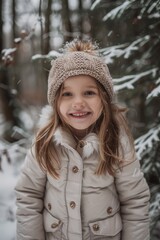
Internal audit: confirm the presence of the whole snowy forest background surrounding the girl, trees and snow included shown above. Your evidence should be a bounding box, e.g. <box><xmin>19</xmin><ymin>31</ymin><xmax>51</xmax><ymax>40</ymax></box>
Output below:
<box><xmin>0</xmin><ymin>0</ymin><xmax>160</xmax><ymax>240</ymax></box>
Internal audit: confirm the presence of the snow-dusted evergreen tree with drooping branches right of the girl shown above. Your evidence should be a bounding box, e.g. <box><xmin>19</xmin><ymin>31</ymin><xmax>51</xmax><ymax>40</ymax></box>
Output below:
<box><xmin>91</xmin><ymin>0</ymin><xmax>160</xmax><ymax>239</ymax></box>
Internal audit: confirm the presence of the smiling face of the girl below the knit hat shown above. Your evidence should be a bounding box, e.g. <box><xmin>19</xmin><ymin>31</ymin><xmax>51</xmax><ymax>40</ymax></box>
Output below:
<box><xmin>58</xmin><ymin>75</ymin><xmax>103</xmax><ymax>133</ymax></box>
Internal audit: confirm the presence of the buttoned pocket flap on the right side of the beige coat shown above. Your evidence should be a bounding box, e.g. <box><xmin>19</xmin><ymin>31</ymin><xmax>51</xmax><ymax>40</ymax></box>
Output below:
<box><xmin>89</xmin><ymin>213</ymin><xmax>122</xmax><ymax>236</ymax></box>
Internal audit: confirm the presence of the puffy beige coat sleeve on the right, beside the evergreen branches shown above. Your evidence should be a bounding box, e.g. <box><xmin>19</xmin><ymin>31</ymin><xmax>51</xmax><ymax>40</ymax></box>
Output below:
<box><xmin>115</xmin><ymin>154</ymin><xmax>150</xmax><ymax>240</ymax></box>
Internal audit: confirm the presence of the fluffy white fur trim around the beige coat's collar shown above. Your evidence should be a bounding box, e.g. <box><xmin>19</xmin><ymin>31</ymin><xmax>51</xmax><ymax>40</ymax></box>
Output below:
<box><xmin>38</xmin><ymin>105</ymin><xmax>99</xmax><ymax>157</ymax></box>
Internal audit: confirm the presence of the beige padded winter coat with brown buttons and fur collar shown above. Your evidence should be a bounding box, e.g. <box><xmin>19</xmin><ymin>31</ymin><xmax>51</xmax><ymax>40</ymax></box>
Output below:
<box><xmin>16</xmin><ymin>106</ymin><xmax>149</xmax><ymax>240</ymax></box>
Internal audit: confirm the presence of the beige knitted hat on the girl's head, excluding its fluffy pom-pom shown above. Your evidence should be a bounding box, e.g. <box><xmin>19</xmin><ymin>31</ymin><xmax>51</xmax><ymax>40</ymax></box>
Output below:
<box><xmin>48</xmin><ymin>45</ymin><xmax>113</xmax><ymax>106</ymax></box>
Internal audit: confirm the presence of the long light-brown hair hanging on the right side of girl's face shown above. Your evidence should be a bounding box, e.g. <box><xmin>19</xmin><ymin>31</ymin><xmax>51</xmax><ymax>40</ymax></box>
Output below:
<box><xmin>94</xmin><ymin>82</ymin><xmax>135</xmax><ymax>176</ymax></box>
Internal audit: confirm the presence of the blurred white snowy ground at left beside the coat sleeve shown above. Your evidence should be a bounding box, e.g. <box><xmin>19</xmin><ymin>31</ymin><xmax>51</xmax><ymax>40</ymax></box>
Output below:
<box><xmin>0</xmin><ymin>142</ymin><xmax>26</xmax><ymax>240</ymax></box>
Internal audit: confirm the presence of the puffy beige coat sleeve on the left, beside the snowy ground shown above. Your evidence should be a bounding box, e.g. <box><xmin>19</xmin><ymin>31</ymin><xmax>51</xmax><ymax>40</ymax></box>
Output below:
<box><xmin>15</xmin><ymin>148</ymin><xmax>46</xmax><ymax>240</ymax></box>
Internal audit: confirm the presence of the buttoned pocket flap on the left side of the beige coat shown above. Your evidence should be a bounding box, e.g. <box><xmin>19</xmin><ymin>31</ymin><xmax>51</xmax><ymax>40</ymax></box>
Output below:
<box><xmin>43</xmin><ymin>209</ymin><xmax>62</xmax><ymax>232</ymax></box>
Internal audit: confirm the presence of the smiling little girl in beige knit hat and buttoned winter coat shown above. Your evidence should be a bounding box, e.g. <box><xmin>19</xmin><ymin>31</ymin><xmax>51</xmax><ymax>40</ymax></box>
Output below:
<box><xmin>16</xmin><ymin>40</ymin><xmax>149</xmax><ymax>240</ymax></box>
